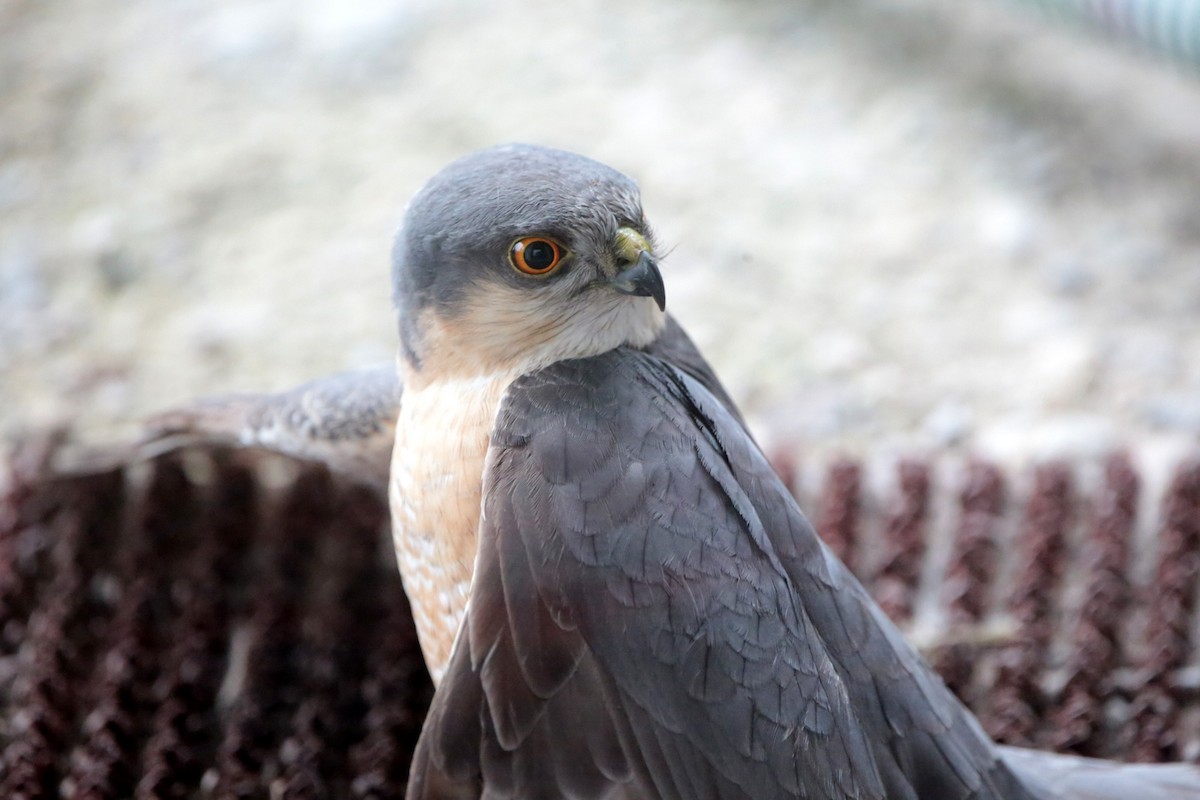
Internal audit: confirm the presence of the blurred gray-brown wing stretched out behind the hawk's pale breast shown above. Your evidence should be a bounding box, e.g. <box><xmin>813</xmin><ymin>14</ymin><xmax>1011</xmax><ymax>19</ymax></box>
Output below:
<box><xmin>145</xmin><ymin>365</ymin><xmax>402</xmax><ymax>488</ymax></box>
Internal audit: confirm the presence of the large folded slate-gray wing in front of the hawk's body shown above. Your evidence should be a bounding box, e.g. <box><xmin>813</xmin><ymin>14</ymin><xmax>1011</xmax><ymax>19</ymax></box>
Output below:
<box><xmin>409</xmin><ymin>350</ymin><xmax>1034</xmax><ymax>800</ymax></box>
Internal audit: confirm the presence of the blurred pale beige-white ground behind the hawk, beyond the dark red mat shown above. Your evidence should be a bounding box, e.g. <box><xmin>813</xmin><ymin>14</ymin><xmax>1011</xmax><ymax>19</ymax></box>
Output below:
<box><xmin>0</xmin><ymin>0</ymin><xmax>1200</xmax><ymax>459</ymax></box>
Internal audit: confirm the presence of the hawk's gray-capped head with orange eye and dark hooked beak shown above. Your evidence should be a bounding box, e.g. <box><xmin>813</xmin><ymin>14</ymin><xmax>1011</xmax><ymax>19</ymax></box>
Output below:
<box><xmin>392</xmin><ymin>145</ymin><xmax>666</xmax><ymax>379</ymax></box>
